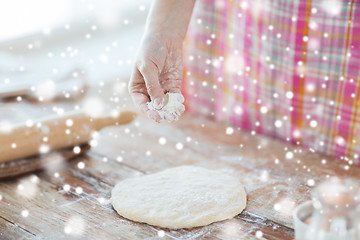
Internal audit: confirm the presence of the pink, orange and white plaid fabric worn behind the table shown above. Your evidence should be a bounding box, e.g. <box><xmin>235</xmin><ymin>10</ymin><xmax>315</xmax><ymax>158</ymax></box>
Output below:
<box><xmin>183</xmin><ymin>0</ymin><xmax>360</xmax><ymax>165</ymax></box>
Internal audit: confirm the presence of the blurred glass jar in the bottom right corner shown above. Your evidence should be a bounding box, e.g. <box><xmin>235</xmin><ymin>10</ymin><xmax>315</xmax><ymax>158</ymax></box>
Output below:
<box><xmin>305</xmin><ymin>177</ymin><xmax>360</xmax><ymax>240</ymax></box>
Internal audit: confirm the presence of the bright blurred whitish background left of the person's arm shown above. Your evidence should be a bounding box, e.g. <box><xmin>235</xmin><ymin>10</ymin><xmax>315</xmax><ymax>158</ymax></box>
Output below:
<box><xmin>0</xmin><ymin>0</ymin><xmax>151</xmax><ymax>96</ymax></box>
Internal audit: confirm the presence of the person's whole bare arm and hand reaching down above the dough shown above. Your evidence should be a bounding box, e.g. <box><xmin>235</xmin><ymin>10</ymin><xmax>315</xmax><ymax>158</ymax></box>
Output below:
<box><xmin>129</xmin><ymin>0</ymin><xmax>195</xmax><ymax>122</ymax></box>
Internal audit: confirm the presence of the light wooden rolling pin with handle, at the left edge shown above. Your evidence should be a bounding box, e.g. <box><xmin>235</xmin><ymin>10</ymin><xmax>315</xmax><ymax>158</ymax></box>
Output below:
<box><xmin>0</xmin><ymin>112</ymin><xmax>135</xmax><ymax>163</ymax></box>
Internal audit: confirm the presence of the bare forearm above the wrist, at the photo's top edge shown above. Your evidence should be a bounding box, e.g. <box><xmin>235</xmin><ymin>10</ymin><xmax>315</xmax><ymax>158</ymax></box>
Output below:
<box><xmin>146</xmin><ymin>0</ymin><xmax>195</xmax><ymax>39</ymax></box>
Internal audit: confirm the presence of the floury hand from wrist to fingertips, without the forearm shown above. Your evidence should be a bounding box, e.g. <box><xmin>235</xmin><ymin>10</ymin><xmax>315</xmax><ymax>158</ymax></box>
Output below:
<box><xmin>129</xmin><ymin>34</ymin><xmax>183</xmax><ymax>122</ymax></box>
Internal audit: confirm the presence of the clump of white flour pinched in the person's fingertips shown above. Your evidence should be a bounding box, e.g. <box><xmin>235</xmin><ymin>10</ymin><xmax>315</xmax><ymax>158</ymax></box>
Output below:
<box><xmin>147</xmin><ymin>93</ymin><xmax>185</xmax><ymax>122</ymax></box>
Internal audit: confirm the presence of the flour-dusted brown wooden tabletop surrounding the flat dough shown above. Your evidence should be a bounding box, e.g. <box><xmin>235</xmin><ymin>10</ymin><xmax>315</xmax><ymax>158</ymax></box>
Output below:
<box><xmin>0</xmin><ymin>82</ymin><xmax>360</xmax><ymax>239</ymax></box>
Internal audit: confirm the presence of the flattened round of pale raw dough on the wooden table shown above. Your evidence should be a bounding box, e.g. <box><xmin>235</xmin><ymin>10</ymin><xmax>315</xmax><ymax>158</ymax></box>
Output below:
<box><xmin>111</xmin><ymin>166</ymin><xmax>246</xmax><ymax>229</ymax></box>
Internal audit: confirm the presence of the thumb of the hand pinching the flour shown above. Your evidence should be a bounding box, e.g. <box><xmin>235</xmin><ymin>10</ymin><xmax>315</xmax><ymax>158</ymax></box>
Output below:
<box><xmin>139</xmin><ymin>62</ymin><xmax>164</xmax><ymax>108</ymax></box>
